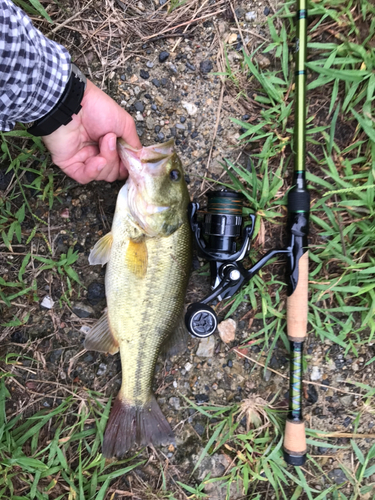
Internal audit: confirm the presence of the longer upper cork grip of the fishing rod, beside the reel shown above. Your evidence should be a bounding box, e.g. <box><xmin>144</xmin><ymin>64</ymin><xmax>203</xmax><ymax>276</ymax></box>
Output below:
<box><xmin>286</xmin><ymin>252</ymin><xmax>309</xmax><ymax>342</ymax></box>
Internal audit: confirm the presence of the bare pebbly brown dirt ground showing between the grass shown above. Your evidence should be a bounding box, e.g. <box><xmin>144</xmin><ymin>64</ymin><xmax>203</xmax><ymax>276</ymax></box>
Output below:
<box><xmin>0</xmin><ymin>0</ymin><xmax>375</xmax><ymax>500</ymax></box>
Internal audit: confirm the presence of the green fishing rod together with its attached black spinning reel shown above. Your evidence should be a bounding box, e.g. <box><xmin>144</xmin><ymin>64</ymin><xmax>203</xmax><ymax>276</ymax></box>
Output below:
<box><xmin>185</xmin><ymin>0</ymin><xmax>310</xmax><ymax>466</ymax></box>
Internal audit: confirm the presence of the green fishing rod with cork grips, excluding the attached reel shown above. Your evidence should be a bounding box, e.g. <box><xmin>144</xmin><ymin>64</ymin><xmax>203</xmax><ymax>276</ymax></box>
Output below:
<box><xmin>284</xmin><ymin>0</ymin><xmax>310</xmax><ymax>465</ymax></box>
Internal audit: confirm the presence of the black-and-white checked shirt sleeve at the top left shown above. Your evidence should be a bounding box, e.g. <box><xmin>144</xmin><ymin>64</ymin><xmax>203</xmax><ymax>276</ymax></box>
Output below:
<box><xmin>0</xmin><ymin>0</ymin><xmax>71</xmax><ymax>131</ymax></box>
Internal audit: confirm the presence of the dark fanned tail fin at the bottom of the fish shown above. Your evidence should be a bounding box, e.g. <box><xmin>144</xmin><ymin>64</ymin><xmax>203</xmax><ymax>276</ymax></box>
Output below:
<box><xmin>103</xmin><ymin>393</ymin><xmax>175</xmax><ymax>458</ymax></box>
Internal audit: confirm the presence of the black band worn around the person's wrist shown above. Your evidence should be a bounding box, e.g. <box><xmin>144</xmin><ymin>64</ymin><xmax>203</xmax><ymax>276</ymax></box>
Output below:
<box><xmin>28</xmin><ymin>63</ymin><xmax>87</xmax><ymax>136</ymax></box>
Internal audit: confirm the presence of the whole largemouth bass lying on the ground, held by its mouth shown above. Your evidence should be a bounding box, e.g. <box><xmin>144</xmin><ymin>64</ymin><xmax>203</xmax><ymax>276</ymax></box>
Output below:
<box><xmin>85</xmin><ymin>139</ymin><xmax>191</xmax><ymax>457</ymax></box>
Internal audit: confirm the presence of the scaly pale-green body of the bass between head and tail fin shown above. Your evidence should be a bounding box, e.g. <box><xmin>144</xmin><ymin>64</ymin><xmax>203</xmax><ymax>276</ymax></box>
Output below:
<box><xmin>106</xmin><ymin>224</ymin><xmax>191</xmax><ymax>405</ymax></box>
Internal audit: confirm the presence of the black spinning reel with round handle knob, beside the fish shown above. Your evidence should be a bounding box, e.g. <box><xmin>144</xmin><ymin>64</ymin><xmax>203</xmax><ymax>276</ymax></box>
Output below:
<box><xmin>185</xmin><ymin>190</ymin><xmax>292</xmax><ymax>338</ymax></box>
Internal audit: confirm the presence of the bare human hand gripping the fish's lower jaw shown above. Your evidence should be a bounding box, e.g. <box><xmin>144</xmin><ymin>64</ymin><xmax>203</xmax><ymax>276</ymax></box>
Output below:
<box><xmin>42</xmin><ymin>80</ymin><xmax>142</xmax><ymax>184</ymax></box>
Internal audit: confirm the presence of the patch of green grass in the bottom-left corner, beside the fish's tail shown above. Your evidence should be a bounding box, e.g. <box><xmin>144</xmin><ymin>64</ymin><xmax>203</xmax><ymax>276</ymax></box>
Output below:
<box><xmin>0</xmin><ymin>373</ymin><xmax>145</xmax><ymax>500</ymax></box>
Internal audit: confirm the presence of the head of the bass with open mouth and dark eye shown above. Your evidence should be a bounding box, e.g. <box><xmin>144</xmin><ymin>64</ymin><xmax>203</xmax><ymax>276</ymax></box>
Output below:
<box><xmin>117</xmin><ymin>139</ymin><xmax>190</xmax><ymax>236</ymax></box>
